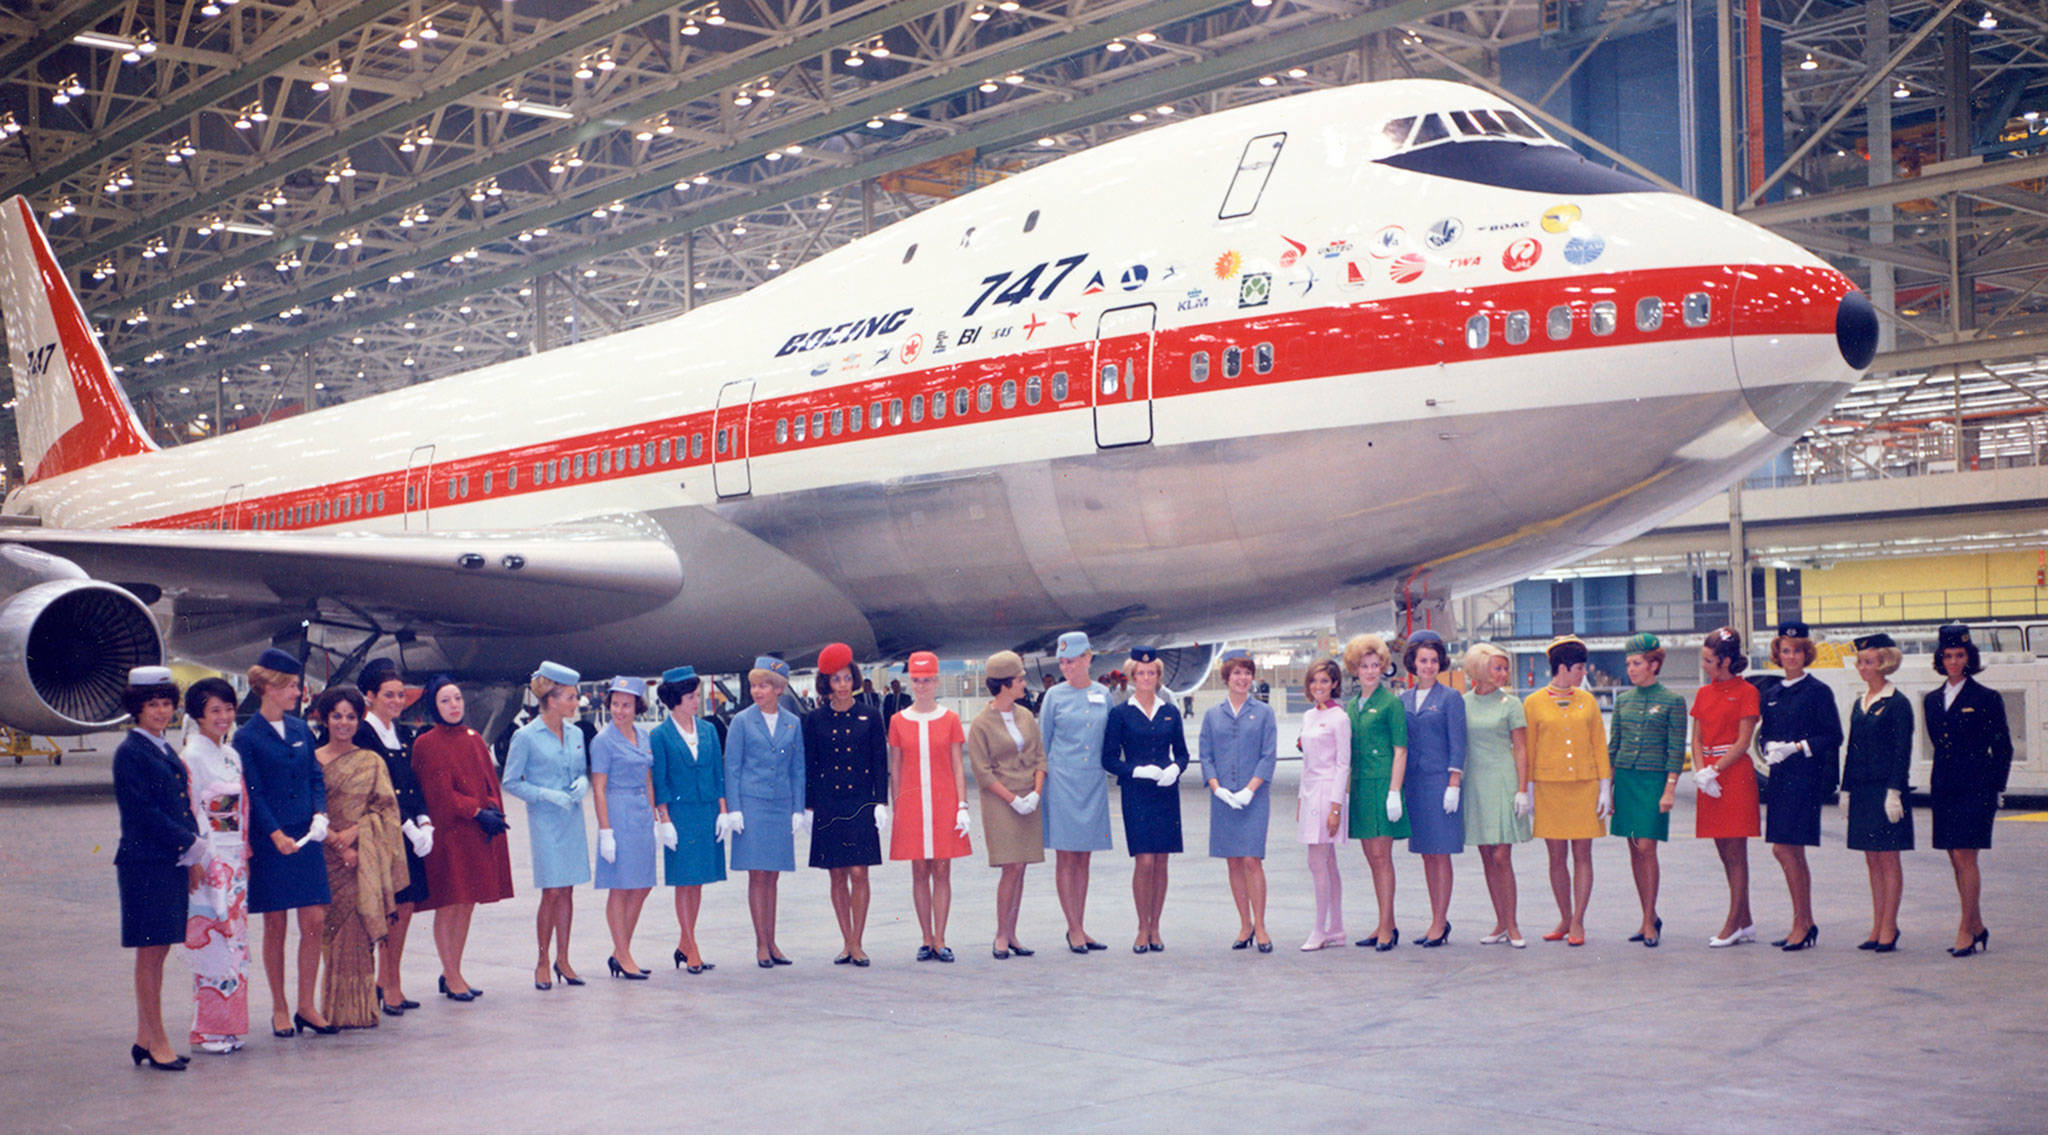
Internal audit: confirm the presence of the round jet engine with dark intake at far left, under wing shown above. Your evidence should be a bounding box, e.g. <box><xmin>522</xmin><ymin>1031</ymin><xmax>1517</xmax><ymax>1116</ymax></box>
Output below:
<box><xmin>0</xmin><ymin>580</ymin><xmax>164</xmax><ymax>733</ymax></box>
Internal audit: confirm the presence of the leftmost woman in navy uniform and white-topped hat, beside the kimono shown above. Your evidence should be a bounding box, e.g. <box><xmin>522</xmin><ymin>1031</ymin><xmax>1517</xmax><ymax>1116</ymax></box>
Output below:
<box><xmin>115</xmin><ymin>666</ymin><xmax>207</xmax><ymax>1071</ymax></box>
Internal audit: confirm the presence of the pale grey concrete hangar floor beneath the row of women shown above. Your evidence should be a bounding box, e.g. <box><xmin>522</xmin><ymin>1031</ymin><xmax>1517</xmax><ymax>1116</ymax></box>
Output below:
<box><xmin>0</xmin><ymin>744</ymin><xmax>2048</xmax><ymax>1133</ymax></box>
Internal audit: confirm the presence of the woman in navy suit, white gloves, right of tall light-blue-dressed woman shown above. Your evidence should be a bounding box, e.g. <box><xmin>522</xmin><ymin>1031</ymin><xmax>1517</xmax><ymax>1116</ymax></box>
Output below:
<box><xmin>1102</xmin><ymin>645</ymin><xmax>1188</xmax><ymax>953</ymax></box>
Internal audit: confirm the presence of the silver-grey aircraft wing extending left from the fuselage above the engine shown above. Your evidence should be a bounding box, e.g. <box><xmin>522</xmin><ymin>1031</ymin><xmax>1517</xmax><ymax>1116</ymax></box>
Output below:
<box><xmin>0</xmin><ymin>516</ymin><xmax>682</xmax><ymax>633</ymax></box>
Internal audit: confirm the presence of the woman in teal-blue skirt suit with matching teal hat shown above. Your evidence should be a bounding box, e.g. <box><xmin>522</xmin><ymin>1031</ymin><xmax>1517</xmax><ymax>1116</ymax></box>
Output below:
<box><xmin>651</xmin><ymin>666</ymin><xmax>725</xmax><ymax>973</ymax></box>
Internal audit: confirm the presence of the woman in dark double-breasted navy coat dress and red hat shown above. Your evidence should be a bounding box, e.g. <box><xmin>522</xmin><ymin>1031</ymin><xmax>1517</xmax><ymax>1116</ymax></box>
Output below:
<box><xmin>803</xmin><ymin>643</ymin><xmax>889</xmax><ymax>967</ymax></box>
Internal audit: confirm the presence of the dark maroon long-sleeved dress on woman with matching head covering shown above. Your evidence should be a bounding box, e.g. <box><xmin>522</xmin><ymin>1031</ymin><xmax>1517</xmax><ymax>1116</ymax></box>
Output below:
<box><xmin>412</xmin><ymin>725</ymin><xmax>512</xmax><ymax>912</ymax></box>
